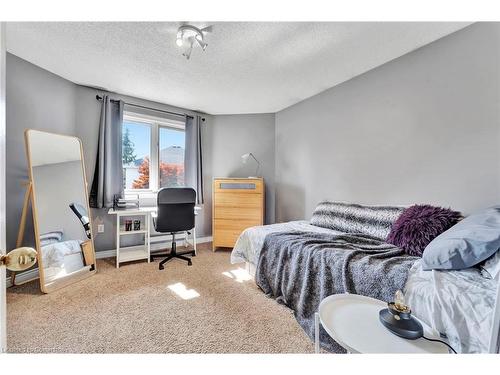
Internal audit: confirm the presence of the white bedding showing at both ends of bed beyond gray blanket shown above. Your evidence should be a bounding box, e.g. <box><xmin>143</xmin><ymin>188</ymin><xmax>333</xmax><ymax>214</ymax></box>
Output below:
<box><xmin>231</xmin><ymin>221</ymin><xmax>496</xmax><ymax>353</ymax></box>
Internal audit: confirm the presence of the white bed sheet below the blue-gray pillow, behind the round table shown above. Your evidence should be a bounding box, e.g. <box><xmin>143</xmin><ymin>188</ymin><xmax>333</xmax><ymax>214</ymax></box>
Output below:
<box><xmin>405</xmin><ymin>261</ymin><xmax>497</xmax><ymax>353</ymax></box>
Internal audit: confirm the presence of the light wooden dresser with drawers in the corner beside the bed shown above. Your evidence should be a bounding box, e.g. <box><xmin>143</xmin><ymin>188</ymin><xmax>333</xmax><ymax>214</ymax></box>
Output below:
<box><xmin>212</xmin><ymin>178</ymin><xmax>264</xmax><ymax>251</ymax></box>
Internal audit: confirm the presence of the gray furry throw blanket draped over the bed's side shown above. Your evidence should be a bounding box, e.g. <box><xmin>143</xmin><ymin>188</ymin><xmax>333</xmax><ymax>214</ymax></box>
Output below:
<box><xmin>255</xmin><ymin>232</ymin><xmax>418</xmax><ymax>353</ymax></box>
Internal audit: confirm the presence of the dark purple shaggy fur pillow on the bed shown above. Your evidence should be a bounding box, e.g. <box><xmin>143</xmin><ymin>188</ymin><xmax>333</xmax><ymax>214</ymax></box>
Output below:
<box><xmin>386</xmin><ymin>204</ymin><xmax>462</xmax><ymax>257</ymax></box>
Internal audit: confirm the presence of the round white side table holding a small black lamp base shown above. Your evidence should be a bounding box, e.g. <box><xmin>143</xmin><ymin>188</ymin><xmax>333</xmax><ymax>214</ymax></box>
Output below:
<box><xmin>315</xmin><ymin>294</ymin><xmax>448</xmax><ymax>353</ymax></box>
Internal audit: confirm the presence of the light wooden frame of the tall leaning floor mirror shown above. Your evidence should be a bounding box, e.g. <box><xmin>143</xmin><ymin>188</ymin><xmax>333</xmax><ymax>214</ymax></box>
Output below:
<box><xmin>24</xmin><ymin>129</ymin><xmax>97</xmax><ymax>293</ymax></box>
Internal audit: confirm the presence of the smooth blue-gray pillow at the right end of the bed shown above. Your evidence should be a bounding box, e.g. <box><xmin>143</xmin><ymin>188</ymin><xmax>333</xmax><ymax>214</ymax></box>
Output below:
<box><xmin>422</xmin><ymin>206</ymin><xmax>500</xmax><ymax>270</ymax></box>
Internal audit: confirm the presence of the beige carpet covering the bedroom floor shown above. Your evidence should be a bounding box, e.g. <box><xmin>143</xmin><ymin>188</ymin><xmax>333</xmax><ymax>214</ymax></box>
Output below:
<box><xmin>7</xmin><ymin>244</ymin><xmax>314</xmax><ymax>353</ymax></box>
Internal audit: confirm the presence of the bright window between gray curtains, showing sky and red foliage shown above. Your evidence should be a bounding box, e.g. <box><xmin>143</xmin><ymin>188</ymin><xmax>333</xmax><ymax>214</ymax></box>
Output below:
<box><xmin>122</xmin><ymin>112</ymin><xmax>185</xmax><ymax>192</ymax></box>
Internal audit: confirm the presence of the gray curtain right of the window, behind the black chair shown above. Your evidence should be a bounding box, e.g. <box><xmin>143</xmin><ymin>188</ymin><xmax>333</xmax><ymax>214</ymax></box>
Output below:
<box><xmin>184</xmin><ymin>116</ymin><xmax>203</xmax><ymax>204</ymax></box>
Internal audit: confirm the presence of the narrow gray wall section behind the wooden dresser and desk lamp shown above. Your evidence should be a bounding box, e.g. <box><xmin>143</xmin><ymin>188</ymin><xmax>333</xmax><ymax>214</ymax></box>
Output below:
<box><xmin>203</xmin><ymin>113</ymin><xmax>275</xmax><ymax>224</ymax></box>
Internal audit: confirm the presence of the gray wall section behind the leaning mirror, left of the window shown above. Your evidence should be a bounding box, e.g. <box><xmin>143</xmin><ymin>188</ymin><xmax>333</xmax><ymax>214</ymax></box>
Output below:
<box><xmin>6</xmin><ymin>54</ymin><xmax>76</xmax><ymax>249</ymax></box>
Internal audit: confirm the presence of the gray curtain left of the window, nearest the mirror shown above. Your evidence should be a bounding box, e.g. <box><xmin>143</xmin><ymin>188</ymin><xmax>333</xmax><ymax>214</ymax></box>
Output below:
<box><xmin>90</xmin><ymin>95</ymin><xmax>124</xmax><ymax>208</ymax></box>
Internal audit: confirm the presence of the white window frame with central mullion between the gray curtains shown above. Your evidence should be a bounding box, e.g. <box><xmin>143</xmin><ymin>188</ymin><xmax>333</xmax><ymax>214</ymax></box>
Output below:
<box><xmin>122</xmin><ymin>111</ymin><xmax>186</xmax><ymax>196</ymax></box>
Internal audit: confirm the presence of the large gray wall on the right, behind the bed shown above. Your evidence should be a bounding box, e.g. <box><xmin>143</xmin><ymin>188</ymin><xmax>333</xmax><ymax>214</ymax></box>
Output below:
<box><xmin>276</xmin><ymin>23</ymin><xmax>500</xmax><ymax>221</ymax></box>
